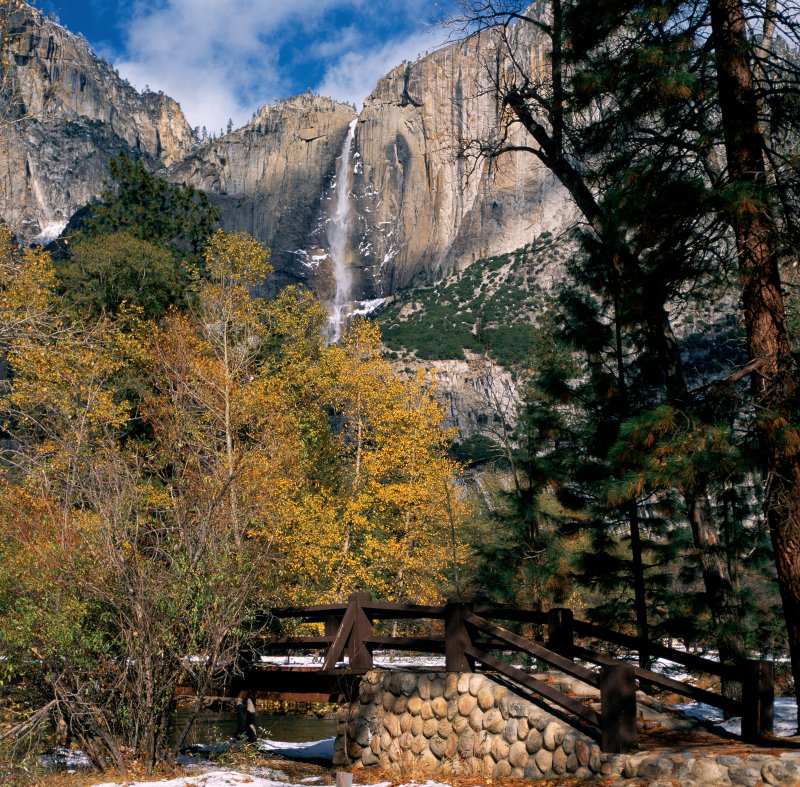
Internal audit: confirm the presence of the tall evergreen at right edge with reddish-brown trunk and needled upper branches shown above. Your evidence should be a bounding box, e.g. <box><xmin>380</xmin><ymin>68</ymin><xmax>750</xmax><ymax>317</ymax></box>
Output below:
<box><xmin>567</xmin><ymin>0</ymin><xmax>800</xmax><ymax>720</ymax></box>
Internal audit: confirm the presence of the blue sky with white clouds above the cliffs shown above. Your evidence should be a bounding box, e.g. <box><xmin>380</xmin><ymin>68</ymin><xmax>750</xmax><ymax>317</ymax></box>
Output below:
<box><xmin>36</xmin><ymin>0</ymin><xmax>454</xmax><ymax>132</ymax></box>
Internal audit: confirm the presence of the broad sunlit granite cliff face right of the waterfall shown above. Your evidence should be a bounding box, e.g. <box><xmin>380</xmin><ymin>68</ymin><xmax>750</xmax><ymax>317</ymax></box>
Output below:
<box><xmin>353</xmin><ymin>28</ymin><xmax>573</xmax><ymax>298</ymax></box>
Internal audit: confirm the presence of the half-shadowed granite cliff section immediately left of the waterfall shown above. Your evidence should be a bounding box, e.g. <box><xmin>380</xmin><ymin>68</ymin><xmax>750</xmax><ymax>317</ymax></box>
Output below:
<box><xmin>163</xmin><ymin>95</ymin><xmax>355</xmax><ymax>295</ymax></box>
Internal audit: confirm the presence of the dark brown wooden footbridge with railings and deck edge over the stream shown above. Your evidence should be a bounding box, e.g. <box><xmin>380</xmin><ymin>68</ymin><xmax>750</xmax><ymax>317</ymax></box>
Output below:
<box><xmin>179</xmin><ymin>592</ymin><xmax>774</xmax><ymax>752</ymax></box>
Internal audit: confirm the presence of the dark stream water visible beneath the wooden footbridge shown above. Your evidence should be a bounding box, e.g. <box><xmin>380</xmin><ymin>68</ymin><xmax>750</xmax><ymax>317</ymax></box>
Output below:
<box><xmin>173</xmin><ymin>708</ymin><xmax>336</xmax><ymax>745</ymax></box>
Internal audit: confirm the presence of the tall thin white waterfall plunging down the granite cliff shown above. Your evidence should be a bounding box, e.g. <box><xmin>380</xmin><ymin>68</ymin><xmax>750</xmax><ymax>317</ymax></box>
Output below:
<box><xmin>325</xmin><ymin>118</ymin><xmax>358</xmax><ymax>343</ymax></box>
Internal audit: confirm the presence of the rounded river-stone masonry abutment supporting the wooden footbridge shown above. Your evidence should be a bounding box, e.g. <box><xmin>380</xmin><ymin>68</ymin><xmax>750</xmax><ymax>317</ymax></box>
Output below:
<box><xmin>333</xmin><ymin>669</ymin><xmax>601</xmax><ymax>779</ymax></box>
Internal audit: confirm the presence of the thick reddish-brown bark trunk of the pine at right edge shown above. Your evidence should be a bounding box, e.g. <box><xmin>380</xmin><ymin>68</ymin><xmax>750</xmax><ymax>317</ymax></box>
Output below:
<box><xmin>709</xmin><ymin>0</ymin><xmax>800</xmax><ymax>728</ymax></box>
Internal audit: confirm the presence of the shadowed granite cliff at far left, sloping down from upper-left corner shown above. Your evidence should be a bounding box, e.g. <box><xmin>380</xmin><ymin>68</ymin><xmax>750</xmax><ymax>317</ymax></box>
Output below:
<box><xmin>0</xmin><ymin>3</ymin><xmax>194</xmax><ymax>238</ymax></box>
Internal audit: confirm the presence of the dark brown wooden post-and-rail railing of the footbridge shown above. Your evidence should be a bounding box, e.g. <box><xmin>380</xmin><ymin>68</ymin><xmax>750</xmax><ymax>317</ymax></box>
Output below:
<box><xmin>252</xmin><ymin>592</ymin><xmax>774</xmax><ymax>752</ymax></box>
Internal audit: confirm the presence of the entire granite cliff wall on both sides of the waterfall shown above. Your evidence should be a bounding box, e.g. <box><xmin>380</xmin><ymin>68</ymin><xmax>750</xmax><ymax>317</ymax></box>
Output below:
<box><xmin>0</xmin><ymin>2</ymin><xmax>572</xmax><ymax>302</ymax></box>
